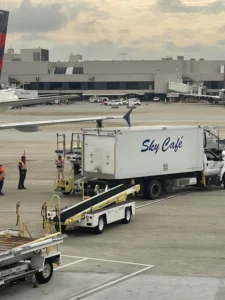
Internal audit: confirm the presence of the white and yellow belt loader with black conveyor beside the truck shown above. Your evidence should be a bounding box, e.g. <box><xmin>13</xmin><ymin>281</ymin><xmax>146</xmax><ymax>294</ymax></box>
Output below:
<box><xmin>47</xmin><ymin>184</ymin><xmax>140</xmax><ymax>233</ymax></box>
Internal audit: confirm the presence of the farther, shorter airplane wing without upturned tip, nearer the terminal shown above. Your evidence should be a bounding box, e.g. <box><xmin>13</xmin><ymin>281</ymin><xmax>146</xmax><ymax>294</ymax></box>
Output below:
<box><xmin>0</xmin><ymin>95</ymin><xmax>79</xmax><ymax>107</ymax></box>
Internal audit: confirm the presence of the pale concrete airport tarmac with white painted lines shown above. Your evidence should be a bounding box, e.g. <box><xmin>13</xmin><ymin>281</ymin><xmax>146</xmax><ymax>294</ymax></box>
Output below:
<box><xmin>0</xmin><ymin>103</ymin><xmax>225</xmax><ymax>300</ymax></box>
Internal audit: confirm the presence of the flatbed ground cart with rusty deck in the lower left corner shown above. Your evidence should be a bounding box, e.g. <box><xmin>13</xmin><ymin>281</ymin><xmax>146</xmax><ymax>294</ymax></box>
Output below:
<box><xmin>0</xmin><ymin>204</ymin><xmax>66</xmax><ymax>286</ymax></box>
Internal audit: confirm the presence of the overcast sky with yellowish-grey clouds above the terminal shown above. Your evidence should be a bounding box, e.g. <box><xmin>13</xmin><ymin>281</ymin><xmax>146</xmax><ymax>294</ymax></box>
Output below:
<box><xmin>1</xmin><ymin>0</ymin><xmax>225</xmax><ymax>61</ymax></box>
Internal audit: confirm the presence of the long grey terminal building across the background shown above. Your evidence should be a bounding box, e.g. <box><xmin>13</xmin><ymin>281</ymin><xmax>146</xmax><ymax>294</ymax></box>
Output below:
<box><xmin>1</xmin><ymin>48</ymin><xmax>225</xmax><ymax>100</ymax></box>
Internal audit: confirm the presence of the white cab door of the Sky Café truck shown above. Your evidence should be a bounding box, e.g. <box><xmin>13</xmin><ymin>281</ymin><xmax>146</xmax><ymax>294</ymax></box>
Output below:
<box><xmin>204</xmin><ymin>150</ymin><xmax>222</xmax><ymax>176</ymax></box>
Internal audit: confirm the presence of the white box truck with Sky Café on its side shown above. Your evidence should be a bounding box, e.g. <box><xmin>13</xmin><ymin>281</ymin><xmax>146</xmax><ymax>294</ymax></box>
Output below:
<box><xmin>82</xmin><ymin>126</ymin><xmax>225</xmax><ymax>199</ymax></box>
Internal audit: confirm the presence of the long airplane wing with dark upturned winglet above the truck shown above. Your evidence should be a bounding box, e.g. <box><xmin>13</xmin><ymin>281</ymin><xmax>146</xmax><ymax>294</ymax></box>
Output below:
<box><xmin>0</xmin><ymin>109</ymin><xmax>132</xmax><ymax>132</ymax></box>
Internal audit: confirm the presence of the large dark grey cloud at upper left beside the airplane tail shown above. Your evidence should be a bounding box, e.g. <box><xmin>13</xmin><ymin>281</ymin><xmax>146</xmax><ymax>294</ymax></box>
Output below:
<box><xmin>9</xmin><ymin>0</ymin><xmax>68</xmax><ymax>33</ymax></box>
